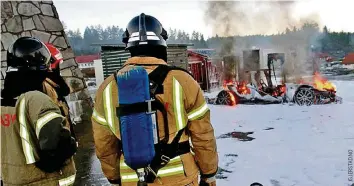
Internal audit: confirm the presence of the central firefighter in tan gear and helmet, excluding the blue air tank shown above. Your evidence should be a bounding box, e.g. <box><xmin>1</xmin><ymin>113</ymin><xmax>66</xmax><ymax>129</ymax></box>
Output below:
<box><xmin>92</xmin><ymin>14</ymin><xmax>218</xmax><ymax>186</ymax></box>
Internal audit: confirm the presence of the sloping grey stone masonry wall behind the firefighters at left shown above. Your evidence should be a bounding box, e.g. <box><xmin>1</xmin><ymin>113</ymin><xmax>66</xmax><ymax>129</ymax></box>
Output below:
<box><xmin>1</xmin><ymin>1</ymin><xmax>92</xmax><ymax>122</ymax></box>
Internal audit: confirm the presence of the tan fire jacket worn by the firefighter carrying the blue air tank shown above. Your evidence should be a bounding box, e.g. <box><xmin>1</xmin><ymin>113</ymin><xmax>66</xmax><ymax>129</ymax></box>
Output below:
<box><xmin>92</xmin><ymin>57</ymin><xmax>218</xmax><ymax>186</ymax></box>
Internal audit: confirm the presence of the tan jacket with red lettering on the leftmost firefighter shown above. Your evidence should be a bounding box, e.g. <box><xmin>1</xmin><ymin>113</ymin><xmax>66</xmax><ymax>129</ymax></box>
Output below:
<box><xmin>1</xmin><ymin>91</ymin><xmax>76</xmax><ymax>186</ymax></box>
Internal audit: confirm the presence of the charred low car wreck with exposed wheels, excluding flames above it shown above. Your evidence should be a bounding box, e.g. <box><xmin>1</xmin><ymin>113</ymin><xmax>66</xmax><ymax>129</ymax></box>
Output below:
<box><xmin>207</xmin><ymin>83</ymin><xmax>342</xmax><ymax>106</ymax></box>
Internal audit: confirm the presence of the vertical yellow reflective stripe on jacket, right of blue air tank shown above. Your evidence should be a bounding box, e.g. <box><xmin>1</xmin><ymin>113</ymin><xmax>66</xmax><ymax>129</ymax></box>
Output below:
<box><xmin>173</xmin><ymin>78</ymin><xmax>185</xmax><ymax>131</ymax></box>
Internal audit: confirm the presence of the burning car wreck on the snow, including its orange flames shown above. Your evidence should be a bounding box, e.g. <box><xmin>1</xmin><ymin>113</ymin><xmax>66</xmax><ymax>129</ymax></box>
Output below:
<box><xmin>207</xmin><ymin>50</ymin><xmax>342</xmax><ymax>106</ymax></box>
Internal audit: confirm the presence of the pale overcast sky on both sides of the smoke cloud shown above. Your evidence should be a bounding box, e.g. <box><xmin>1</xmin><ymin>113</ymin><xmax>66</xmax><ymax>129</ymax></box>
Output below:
<box><xmin>54</xmin><ymin>0</ymin><xmax>354</xmax><ymax>37</ymax></box>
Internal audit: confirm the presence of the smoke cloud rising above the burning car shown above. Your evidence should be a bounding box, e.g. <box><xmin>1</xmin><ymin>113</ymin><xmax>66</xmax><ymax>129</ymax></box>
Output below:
<box><xmin>204</xmin><ymin>1</ymin><xmax>322</xmax><ymax>80</ymax></box>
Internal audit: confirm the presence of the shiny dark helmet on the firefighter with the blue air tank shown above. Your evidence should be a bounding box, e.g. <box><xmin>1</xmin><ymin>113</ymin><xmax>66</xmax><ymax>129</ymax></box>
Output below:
<box><xmin>123</xmin><ymin>13</ymin><xmax>168</xmax><ymax>49</ymax></box>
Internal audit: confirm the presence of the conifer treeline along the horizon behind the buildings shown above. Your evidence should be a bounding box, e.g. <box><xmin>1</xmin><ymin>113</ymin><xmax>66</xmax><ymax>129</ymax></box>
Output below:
<box><xmin>66</xmin><ymin>23</ymin><xmax>354</xmax><ymax>58</ymax></box>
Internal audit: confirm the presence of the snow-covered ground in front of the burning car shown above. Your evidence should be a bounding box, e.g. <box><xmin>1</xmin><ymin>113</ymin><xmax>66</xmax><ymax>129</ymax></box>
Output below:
<box><xmin>209</xmin><ymin>81</ymin><xmax>354</xmax><ymax>186</ymax></box>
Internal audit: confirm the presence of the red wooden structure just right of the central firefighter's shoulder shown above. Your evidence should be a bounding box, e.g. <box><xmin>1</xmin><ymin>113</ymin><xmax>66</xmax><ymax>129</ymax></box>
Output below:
<box><xmin>187</xmin><ymin>50</ymin><xmax>220</xmax><ymax>91</ymax></box>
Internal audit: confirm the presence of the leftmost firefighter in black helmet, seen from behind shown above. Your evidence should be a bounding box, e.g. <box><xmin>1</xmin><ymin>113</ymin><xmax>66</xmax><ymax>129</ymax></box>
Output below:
<box><xmin>1</xmin><ymin>37</ymin><xmax>77</xmax><ymax>186</ymax></box>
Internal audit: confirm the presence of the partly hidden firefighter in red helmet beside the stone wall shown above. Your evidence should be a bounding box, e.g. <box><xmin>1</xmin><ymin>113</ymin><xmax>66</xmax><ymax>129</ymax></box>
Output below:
<box><xmin>43</xmin><ymin>43</ymin><xmax>76</xmax><ymax>139</ymax></box>
